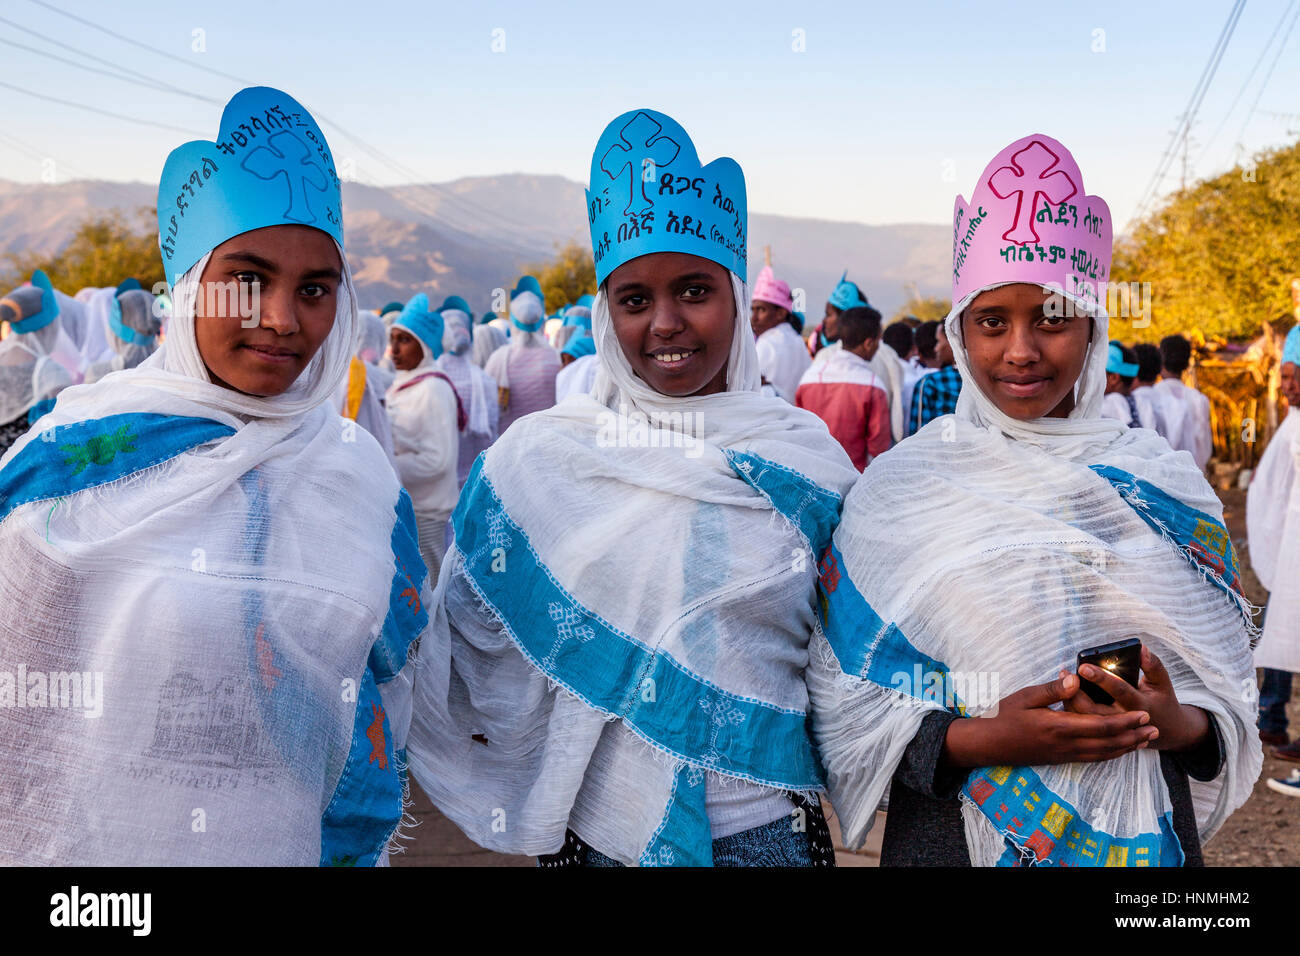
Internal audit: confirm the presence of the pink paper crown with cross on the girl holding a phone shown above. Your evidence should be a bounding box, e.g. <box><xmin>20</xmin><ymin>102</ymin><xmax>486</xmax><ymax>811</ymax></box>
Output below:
<box><xmin>953</xmin><ymin>133</ymin><xmax>1112</xmax><ymax>307</ymax></box>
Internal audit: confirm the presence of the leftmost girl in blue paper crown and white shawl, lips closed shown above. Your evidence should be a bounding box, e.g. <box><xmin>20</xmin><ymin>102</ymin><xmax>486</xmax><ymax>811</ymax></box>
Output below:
<box><xmin>0</xmin><ymin>87</ymin><xmax>429</xmax><ymax>865</ymax></box>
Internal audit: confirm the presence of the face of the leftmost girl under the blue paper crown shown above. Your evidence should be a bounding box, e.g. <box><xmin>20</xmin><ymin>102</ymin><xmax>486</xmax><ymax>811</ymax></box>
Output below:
<box><xmin>194</xmin><ymin>225</ymin><xmax>343</xmax><ymax>398</ymax></box>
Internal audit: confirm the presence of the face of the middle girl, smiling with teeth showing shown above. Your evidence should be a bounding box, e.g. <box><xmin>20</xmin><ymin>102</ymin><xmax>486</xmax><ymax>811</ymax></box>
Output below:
<box><xmin>606</xmin><ymin>252</ymin><xmax>736</xmax><ymax>398</ymax></box>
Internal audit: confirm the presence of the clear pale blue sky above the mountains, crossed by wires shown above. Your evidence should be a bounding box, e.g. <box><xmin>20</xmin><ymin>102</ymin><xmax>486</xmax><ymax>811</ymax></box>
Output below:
<box><xmin>0</xmin><ymin>0</ymin><xmax>1300</xmax><ymax>231</ymax></box>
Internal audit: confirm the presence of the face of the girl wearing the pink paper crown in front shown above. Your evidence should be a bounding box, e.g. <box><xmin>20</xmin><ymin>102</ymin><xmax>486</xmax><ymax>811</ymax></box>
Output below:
<box><xmin>961</xmin><ymin>282</ymin><xmax>1092</xmax><ymax>421</ymax></box>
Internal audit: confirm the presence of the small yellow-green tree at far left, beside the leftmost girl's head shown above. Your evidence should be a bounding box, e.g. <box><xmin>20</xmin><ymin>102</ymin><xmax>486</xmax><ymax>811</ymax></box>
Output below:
<box><xmin>0</xmin><ymin>208</ymin><xmax>164</xmax><ymax>295</ymax></box>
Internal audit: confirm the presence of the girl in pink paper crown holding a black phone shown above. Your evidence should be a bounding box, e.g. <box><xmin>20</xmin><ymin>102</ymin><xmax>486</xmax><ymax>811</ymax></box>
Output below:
<box><xmin>809</xmin><ymin>135</ymin><xmax>1261</xmax><ymax>866</ymax></box>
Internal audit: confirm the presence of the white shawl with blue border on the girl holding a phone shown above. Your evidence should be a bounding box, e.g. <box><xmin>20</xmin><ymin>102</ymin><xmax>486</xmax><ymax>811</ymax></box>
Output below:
<box><xmin>809</xmin><ymin>290</ymin><xmax>1261</xmax><ymax>865</ymax></box>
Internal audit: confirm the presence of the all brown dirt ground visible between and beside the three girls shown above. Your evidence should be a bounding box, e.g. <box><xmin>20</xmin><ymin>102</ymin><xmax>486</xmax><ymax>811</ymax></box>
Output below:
<box><xmin>393</xmin><ymin>490</ymin><xmax>1300</xmax><ymax>866</ymax></box>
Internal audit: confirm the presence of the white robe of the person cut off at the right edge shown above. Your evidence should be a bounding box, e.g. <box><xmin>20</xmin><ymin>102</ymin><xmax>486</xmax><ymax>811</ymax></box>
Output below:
<box><xmin>1245</xmin><ymin>408</ymin><xmax>1300</xmax><ymax>671</ymax></box>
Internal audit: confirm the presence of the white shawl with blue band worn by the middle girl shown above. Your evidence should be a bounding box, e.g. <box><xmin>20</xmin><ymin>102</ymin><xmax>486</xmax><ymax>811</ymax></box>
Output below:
<box><xmin>411</xmin><ymin>280</ymin><xmax>857</xmax><ymax>865</ymax></box>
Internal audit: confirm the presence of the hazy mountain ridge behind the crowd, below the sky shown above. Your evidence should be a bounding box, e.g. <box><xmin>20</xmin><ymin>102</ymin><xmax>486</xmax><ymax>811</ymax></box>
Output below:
<box><xmin>0</xmin><ymin>174</ymin><xmax>950</xmax><ymax>320</ymax></box>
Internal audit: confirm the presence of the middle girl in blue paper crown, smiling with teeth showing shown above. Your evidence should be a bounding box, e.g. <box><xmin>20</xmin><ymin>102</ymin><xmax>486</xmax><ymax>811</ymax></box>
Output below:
<box><xmin>411</xmin><ymin>109</ymin><xmax>857</xmax><ymax>866</ymax></box>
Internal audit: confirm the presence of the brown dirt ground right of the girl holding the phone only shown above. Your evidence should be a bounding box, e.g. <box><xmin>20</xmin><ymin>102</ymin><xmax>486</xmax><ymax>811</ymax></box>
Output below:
<box><xmin>1205</xmin><ymin>490</ymin><xmax>1300</xmax><ymax>866</ymax></box>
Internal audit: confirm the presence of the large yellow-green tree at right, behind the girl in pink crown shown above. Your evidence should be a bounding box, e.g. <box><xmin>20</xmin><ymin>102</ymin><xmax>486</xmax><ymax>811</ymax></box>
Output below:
<box><xmin>1112</xmin><ymin>143</ymin><xmax>1300</xmax><ymax>342</ymax></box>
